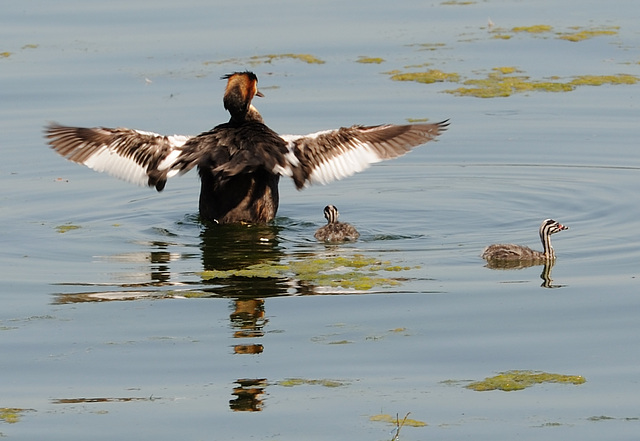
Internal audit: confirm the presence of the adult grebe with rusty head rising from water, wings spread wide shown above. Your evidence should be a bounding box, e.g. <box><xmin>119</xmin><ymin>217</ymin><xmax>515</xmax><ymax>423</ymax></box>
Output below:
<box><xmin>46</xmin><ymin>71</ymin><xmax>449</xmax><ymax>223</ymax></box>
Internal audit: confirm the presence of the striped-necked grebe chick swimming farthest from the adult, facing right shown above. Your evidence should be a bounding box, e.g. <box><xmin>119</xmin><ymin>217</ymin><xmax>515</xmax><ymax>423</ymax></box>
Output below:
<box><xmin>482</xmin><ymin>219</ymin><xmax>569</xmax><ymax>262</ymax></box>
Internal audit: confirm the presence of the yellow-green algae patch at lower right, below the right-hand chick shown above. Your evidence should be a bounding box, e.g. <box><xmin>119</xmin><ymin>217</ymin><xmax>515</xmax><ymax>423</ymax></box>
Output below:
<box><xmin>465</xmin><ymin>371</ymin><xmax>586</xmax><ymax>392</ymax></box>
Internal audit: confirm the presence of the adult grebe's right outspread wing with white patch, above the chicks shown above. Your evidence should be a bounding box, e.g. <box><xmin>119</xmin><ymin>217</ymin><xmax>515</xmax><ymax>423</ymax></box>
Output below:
<box><xmin>282</xmin><ymin>121</ymin><xmax>449</xmax><ymax>189</ymax></box>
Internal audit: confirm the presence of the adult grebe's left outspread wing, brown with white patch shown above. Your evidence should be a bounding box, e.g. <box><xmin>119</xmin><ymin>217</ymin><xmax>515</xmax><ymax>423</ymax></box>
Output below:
<box><xmin>45</xmin><ymin>124</ymin><xmax>195</xmax><ymax>191</ymax></box>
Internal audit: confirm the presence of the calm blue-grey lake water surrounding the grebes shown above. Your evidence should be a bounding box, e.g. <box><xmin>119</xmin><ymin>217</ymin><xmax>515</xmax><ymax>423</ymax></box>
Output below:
<box><xmin>0</xmin><ymin>0</ymin><xmax>640</xmax><ymax>441</ymax></box>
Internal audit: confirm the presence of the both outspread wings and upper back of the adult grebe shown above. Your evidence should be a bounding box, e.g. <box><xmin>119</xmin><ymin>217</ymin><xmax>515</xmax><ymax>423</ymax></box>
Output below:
<box><xmin>45</xmin><ymin>121</ymin><xmax>449</xmax><ymax>191</ymax></box>
